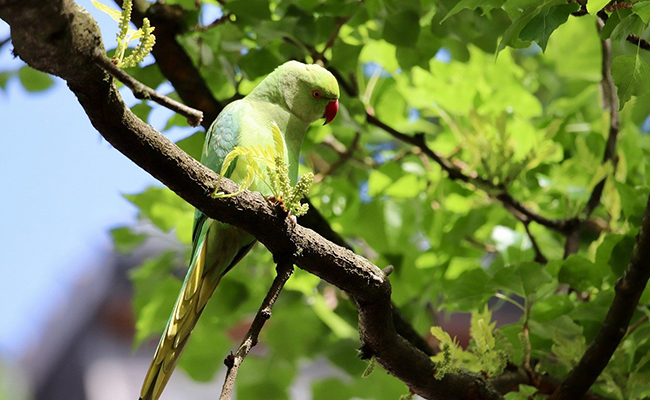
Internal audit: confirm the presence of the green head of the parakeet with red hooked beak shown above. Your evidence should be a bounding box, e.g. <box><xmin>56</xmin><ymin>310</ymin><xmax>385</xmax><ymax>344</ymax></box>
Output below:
<box><xmin>256</xmin><ymin>61</ymin><xmax>339</xmax><ymax>124</ymax></box>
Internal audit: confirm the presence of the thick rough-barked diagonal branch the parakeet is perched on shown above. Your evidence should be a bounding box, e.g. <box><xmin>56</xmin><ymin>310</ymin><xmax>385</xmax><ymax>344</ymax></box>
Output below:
<box><xmin>0</xmin><ymin>0</ymin><xmax>494</xmax><ymax>400</ymax></box>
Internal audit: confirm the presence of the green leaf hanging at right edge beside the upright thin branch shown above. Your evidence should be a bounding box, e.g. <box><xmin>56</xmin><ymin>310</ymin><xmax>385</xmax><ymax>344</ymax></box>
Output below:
<box><xmin>612</xmin><ymin>54</ymin><xmax>650</xmax><ymax>109</ymax></box>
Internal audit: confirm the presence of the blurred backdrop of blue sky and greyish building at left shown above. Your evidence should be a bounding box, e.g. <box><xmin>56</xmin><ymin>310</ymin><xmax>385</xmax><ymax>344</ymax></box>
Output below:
<box><xmin>0</xmin><ymin>0</ymin><xmax>208</xmax><ymax>400</ymax></box>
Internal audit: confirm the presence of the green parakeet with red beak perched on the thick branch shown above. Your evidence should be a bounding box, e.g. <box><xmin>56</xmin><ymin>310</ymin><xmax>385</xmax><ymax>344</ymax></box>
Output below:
<box><xmin>140</xmin><ymin>61</ymin><xmax>339</xmax><ymax>400</ymax></box>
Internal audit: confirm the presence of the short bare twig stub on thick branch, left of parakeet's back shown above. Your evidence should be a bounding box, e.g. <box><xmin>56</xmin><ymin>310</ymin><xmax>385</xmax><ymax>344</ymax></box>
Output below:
<box><xmin>93</xmin><ymin>50</ymin><xmax>203</xmax><ymax>126</ymax></box>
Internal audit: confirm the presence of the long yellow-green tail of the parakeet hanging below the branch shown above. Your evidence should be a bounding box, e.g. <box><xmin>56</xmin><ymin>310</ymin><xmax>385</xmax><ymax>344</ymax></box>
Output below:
<box><xmin>140</xmin><ymin>231</ymin><xmax>221</xmax><ymax>400</ymax></box>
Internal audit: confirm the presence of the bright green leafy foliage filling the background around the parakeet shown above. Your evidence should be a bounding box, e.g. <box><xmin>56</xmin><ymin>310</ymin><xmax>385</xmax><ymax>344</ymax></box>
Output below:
<box><xmin>6</xmin><ymin>0</ymin><xmax>650</xmax><ymax>399</ymax></box>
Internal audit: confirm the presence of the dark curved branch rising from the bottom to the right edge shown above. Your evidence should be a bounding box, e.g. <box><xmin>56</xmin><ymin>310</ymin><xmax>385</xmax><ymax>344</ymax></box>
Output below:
<box><xmin>549</xmin><ymin>192</ymin><xmax>650</xmax><ymax>400</ymax></box>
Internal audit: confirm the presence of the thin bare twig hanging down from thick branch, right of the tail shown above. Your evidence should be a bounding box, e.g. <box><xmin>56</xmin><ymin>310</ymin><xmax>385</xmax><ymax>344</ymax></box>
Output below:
<box><xmin>219</xmin><ymin>261</ymin><xmax>293</xmax><ymax>400</ymax></box>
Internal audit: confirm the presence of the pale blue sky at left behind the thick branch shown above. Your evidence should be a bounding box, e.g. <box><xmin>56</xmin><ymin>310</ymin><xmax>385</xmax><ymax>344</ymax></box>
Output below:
<box><xmin>0</xmin><ymin>0</ymin><xmax>197</xmax><ymax>360</ymax></box>
